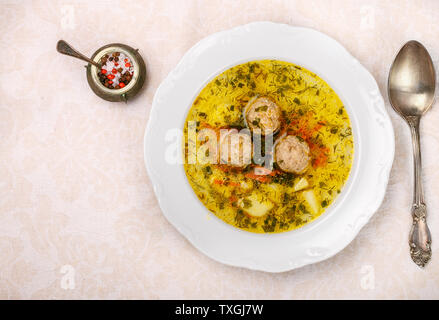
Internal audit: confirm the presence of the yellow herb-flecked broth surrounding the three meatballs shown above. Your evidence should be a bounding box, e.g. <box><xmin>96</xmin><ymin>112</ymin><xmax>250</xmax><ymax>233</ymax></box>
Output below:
<box><xmin>184</xmin><ymin>60</ymin><xmax>353</xmax><ymax>233</ymax></box>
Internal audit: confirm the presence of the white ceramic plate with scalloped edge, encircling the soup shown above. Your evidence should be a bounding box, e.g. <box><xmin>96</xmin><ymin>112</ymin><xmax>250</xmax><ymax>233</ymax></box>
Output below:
<box><xmin>145</xmin><ymin>22</ymin><xmax>394</xmax><ymax>272</ymax></box>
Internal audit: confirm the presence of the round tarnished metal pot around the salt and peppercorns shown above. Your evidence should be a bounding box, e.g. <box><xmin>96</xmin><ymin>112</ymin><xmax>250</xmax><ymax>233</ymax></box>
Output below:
<box><xmin>86</xmin><ymin>43</ymin><xmax>146</xmax><ymax>102</ymax></box>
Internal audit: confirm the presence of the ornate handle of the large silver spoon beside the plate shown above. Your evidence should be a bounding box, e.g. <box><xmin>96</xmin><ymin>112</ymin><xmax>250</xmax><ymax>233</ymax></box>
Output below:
<box><xmin>407</xmin><ymin>116</ymin><xmax>431</xmax><ymax>267</ymax></box>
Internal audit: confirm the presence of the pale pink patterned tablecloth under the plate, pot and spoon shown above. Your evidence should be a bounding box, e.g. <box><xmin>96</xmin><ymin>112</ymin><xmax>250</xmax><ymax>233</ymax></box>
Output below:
<box><xmin>0</xmin><ymin>0</ymin><xmax>439</xmax><ymax>299</ymax></box>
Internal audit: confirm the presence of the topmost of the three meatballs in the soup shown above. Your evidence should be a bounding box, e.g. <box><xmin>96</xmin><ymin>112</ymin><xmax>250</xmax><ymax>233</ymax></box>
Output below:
<box><xmin>244</xmin><ymin>97</ymin><xmax>281</xmax><ymax>135</ymax></box>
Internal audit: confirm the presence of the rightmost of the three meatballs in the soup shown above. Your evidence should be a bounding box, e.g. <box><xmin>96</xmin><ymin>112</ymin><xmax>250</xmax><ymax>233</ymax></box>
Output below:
<box><xmin>274</xmin><ymin>135</ymin><xmax>310</xmax><ymax>173</ymax></box>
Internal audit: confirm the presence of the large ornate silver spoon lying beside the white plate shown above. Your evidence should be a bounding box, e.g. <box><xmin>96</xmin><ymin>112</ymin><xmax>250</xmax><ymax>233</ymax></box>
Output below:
<box><xmin>388</xmin><ymin>40</ymin><xmax>436</xmax><ymax>267</ymax></box>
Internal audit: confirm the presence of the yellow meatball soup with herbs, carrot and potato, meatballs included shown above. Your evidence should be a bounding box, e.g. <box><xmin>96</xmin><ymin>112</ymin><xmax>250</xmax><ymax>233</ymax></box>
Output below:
<box><xmin>184</xmin><ymin>60</ymin><xmax>354</xmax><ymax>233</ymax></box>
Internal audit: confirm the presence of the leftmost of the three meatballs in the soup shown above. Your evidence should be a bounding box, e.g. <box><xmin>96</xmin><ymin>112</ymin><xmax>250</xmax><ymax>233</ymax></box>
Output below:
<box><xmin>220</xmin><ymin>130</ymin><xmax>252</xmax><ymax>167</ymax></box>
